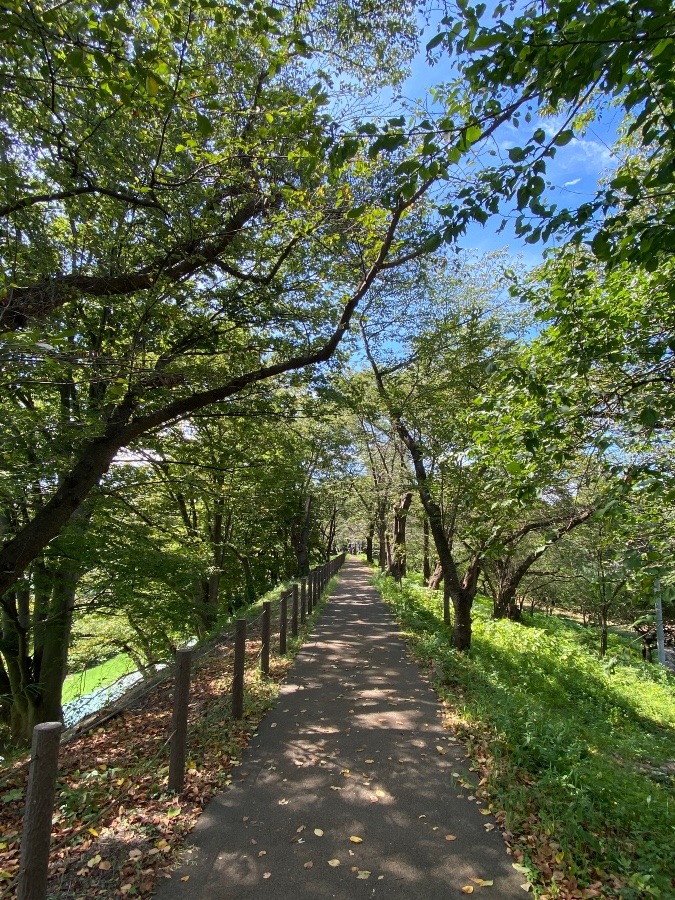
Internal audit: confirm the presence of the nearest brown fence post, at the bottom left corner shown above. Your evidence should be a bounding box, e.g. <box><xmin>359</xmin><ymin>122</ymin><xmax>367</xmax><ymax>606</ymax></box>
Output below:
<box><xmin>16</xmin><ymin>722</ymin><xmax>63</xmax><ymax>900</ymax></box>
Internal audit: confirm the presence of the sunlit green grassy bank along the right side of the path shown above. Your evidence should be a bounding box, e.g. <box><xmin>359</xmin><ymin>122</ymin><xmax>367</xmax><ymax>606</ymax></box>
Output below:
<box><xmin>375</xmin><ymin>575</ymin><xmax>675</xmax><ymax>900</ymax></box>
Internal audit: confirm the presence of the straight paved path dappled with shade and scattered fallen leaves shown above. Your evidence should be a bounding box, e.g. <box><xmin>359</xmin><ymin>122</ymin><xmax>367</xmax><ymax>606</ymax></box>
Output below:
<box><xmin>156</xmin><ymin>561</ymin><xmax>524</xmax><ymax>900</ymax></box>
